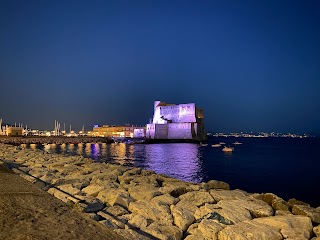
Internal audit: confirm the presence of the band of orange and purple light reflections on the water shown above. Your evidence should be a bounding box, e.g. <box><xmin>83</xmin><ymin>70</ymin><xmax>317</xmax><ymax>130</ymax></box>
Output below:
<box><xmin>25</xmin><ymin>143</ymin><xmax>204</xmax><ymax>182</ymax></box>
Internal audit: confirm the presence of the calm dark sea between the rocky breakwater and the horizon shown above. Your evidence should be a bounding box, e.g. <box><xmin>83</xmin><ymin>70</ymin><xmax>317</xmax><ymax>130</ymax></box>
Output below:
<box><xmin>21</xmin><ymin>137</ymin><xmax>320</xmax><ymax>207</ymax></box>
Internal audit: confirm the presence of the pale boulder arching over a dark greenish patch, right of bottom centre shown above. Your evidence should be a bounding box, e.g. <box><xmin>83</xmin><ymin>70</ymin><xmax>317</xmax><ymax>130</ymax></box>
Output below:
<box><xmin>194</xmin><ymin>200</ymin><xmax>252</xmax><ymax>223</ymax></box>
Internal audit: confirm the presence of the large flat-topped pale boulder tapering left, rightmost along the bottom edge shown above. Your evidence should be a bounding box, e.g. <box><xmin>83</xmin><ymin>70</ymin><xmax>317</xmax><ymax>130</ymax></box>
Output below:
<box><xmin>253</xmin><ymin>215</ymin><xmax>312</xmax><ymax>239</ymax></box>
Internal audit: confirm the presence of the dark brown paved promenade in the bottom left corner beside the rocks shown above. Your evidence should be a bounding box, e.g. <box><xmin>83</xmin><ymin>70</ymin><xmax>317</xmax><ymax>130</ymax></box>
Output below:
<box><xmin>0</xmin><ymin>164</ymin><xmax>123</xmax><ymax>240</ymax></box>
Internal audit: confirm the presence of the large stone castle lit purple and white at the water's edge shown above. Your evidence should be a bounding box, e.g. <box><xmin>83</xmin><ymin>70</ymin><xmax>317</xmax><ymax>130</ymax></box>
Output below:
<box><xmin>146</xmin><ymin>101</ymin><xmax>206</xmax><ymax>141</ymax></box>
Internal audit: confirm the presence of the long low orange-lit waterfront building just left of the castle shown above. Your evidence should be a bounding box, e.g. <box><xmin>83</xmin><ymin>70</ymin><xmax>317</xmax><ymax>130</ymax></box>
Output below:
<box><xmin>92</xmin><ymin>125</ymin><xmax>145</xmax><ymax>138</ymax></box>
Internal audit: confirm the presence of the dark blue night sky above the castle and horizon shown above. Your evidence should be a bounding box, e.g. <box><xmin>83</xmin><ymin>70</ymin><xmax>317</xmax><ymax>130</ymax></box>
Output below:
<box><xmin>0</xmin><ymin>0</ymin><xmax>320</xmax><ymax>132</ymax></box>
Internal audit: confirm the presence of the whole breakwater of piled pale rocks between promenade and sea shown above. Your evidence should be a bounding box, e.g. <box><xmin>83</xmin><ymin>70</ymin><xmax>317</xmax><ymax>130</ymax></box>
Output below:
<box><xmin>0</xmin><ymin>144</ymin><xmax>320</xmax><ymax>240</ymax></box>
